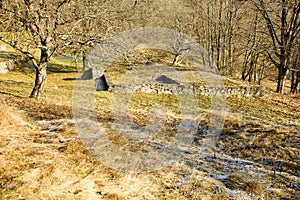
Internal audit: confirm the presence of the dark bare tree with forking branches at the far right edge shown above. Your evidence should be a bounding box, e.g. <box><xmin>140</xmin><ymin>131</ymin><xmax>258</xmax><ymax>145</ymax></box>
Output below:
<box><xmin>251</xmin><ymin>0</ymin><xmax>300</xmax><ymax>94</ymax></box>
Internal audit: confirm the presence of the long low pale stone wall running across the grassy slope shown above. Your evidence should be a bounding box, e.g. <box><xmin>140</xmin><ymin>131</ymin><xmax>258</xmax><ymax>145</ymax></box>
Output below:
<box><xmin>112</xmin><ymin>84</ymin><xmax>263</xmax><ymax>97</ymax></box>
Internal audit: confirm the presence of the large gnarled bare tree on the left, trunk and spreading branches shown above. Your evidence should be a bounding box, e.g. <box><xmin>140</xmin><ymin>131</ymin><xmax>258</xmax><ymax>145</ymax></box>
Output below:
<box><xmin>0</xmin><ymin>0</ymin><xmax>101</xmax><ymax>99</ymax></box>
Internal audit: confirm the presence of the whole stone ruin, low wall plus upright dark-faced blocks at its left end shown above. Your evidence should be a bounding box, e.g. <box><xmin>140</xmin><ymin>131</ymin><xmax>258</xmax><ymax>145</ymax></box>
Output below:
<box><xmin>81</xmin><ymin>68</ymin><xmax>264</xmax><ymax>97</ymax></box>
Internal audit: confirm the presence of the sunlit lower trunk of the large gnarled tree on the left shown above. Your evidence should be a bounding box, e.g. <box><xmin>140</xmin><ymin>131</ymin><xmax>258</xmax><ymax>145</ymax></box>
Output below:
<box><xmin>30</xmin><ymin>63</ymin><xmax>48</xmax><ymax>99</ymax></box>
